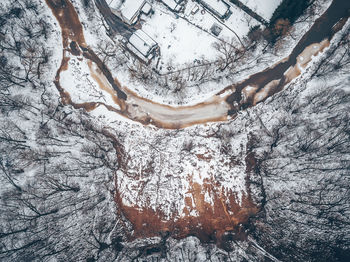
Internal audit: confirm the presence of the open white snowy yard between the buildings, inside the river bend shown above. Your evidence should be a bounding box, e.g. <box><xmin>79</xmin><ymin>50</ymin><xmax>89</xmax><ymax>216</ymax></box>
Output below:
<box><xmin>142</xmin><ymin>1</ymin><xmax>259</xmax><ymax>68</ymax></box>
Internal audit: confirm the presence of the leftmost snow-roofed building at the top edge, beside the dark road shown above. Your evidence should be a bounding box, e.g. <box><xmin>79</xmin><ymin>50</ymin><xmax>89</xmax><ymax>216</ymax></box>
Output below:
<box><xmin>108</xmin><ymin>0</ymin><xmax>152</xmax><ymax>25</ymax></box>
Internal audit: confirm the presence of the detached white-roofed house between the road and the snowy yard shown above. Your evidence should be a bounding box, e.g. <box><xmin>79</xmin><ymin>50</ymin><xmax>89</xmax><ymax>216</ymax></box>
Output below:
<box><xmin>126</xmin><ymin>29</ymin><xmax>158</xmax><ymax>63</ymax></box>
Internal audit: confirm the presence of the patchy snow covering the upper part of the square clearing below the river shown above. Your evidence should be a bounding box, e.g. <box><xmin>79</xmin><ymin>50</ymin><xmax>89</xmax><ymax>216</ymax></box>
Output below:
<box><xmin>116</xmin><ymin>121</ymin><xmax>247</xmax><ymax>218</ymax></box>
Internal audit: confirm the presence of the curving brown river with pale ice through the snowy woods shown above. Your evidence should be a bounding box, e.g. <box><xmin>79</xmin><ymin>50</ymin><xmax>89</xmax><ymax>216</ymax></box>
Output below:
<box><xmin>46</xmin><ymin>0</ymin><xmax>350</xmax><ymax>129</ymax></box>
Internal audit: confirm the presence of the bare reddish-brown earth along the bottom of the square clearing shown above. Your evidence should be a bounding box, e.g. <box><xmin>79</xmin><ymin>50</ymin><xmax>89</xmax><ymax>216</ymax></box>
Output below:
<box><xmin>115</xmin><ymin>178</ymin><xmax>258</xmax><ymax>246</ymax></box>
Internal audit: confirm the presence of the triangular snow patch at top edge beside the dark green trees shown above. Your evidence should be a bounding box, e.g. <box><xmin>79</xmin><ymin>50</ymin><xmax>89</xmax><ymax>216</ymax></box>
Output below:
<box><xmin>241</xmin><ymin>0</ymin><xmax>282</xmax><ymax>21</ymax></box>
